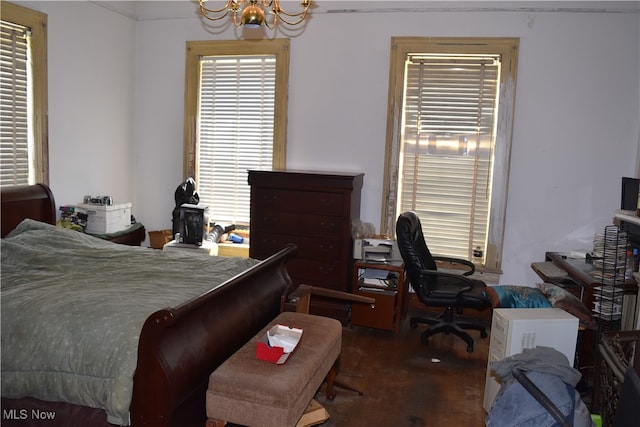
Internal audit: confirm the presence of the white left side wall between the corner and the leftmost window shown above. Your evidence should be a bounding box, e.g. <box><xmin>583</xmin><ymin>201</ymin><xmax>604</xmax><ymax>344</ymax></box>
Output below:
<box><xmin>24</xmin><ymin>2</ymin><xmax>136</xmax><ymax>209</ymax></box>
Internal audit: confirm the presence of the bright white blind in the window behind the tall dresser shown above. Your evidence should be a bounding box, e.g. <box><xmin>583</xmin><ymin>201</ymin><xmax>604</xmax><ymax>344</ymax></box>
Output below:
<box><xmin>196</xmin><ymin>55</ymin><xmax>276</xmax><ymax>224</ymax></box>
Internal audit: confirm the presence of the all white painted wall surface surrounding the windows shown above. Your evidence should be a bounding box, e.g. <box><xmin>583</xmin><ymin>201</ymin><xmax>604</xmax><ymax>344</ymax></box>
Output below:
<box><xmin>16</xmin><ymin>1</ymin><xmax>640</xmax><ymax>284</ymax></box>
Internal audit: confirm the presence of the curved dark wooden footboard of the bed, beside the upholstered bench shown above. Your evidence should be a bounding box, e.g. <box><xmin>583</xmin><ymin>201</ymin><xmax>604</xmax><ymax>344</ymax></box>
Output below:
<box><xmin>131</xmin><ymin>245</ymin><xmax>297</xmax><ymax>427</ymax></box>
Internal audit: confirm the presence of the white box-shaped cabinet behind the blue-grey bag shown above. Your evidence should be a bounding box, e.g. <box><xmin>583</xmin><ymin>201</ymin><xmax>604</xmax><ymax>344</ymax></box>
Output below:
<box><xmin>483</xmin><ymin>308</ymin><xmax>578</xmax><ymax>412</ymax></box>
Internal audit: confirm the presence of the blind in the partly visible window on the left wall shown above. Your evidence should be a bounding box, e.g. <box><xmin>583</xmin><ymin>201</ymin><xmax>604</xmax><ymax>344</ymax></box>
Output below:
<box><xmin>0</xmin><ymin>21</ymin><xmax>33</xmax><ymax>186</ymax></box>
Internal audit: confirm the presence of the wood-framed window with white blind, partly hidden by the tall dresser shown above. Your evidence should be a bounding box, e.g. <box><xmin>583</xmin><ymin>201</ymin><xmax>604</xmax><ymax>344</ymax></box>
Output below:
<box><xmin>184</xmin><ymin>39</ymin><xmax>289</xmax><ymax>224</ymax></box>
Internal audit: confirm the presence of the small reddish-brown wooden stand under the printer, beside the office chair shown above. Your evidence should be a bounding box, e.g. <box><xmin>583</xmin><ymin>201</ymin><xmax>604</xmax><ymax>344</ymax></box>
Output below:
<box><xmin>351</xmin><ymin>260</ymin><xmax>409</xmax><ymax>334</ymax></box>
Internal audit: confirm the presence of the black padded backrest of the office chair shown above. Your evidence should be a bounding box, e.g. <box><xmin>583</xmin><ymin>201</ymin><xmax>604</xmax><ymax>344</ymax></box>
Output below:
<box><xmin>396</xmin><ymin>211</ymin><xmax>437</xmax><ymax>289</ymax></box>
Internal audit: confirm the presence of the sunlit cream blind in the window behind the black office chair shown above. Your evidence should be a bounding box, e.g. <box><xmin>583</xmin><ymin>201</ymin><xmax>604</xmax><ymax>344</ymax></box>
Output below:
<box><xmin>397</xmin><ymin>54</ymin><xmax>500</xmax><ymax>259</ymax></box>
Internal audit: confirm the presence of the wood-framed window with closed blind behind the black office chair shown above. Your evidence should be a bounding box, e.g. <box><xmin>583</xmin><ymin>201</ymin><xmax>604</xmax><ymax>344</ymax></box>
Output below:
<box><xmin>382</xmin><ymin>38</ymin><xmax>519</xmax><ymax>273</ymax></box>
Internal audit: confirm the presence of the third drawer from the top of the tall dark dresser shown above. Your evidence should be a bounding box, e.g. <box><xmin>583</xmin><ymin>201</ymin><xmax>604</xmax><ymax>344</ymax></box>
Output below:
<box><xmin>251</xmin><ymin>233</ymin><xmax>348</xmax><ymax>261</ymax></box>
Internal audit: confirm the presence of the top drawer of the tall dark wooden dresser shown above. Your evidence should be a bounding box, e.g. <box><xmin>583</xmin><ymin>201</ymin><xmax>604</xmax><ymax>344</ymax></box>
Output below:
<box><xmin>251</xmin><ymin>188</ymin><xmax>346</xmax><ymax>216</ymax></box>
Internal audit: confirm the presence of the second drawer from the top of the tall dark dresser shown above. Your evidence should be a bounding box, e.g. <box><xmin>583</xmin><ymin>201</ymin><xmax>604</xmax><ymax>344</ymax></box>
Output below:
<box><xmin>251</xmin><ymin>210</ymin><xmax>351</xmax><ymax>239</ymax></box>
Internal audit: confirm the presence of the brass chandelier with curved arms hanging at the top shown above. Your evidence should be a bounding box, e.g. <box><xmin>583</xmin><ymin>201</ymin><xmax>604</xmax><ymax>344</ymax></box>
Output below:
<box><xmin>197</xmin><ymin>0</ymin><xmax>311</xmax><ymax>29</ymax></box>
